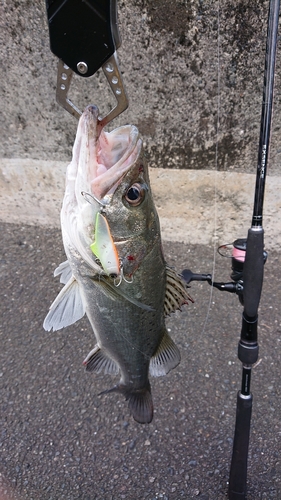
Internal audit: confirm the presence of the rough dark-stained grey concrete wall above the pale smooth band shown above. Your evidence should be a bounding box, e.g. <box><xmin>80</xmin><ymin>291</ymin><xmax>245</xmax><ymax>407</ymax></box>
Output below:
<box><xmin>0</xmin><ymin>0</ymin><xmax>281</xmax><ymax>175</ymax></box>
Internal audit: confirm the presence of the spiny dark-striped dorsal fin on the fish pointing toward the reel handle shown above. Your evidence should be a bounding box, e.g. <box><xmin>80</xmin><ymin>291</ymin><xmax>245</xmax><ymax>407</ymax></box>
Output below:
<box><xmin>164</xmin><ymin>265</ymin><xmax>194</xmax><ymax>316</ymax></box>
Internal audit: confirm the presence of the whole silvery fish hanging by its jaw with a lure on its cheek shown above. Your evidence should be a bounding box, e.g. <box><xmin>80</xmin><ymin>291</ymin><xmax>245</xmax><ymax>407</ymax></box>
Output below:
<box><xmin>43</xmin><ymin>105</ymin><xmax>192</xmax><ymax>424</ymax></box>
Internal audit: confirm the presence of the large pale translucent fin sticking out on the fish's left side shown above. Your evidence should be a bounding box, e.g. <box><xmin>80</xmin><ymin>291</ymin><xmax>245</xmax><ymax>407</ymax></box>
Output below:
<box><xmin>43</xmin><ymin>276</ymin><xmax>86</xmax><ymax>332</ymax></box>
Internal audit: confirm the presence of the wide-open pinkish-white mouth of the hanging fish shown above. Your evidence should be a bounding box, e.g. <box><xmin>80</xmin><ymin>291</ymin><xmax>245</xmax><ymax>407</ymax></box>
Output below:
<box><xmin>79</xmin><ymin>105</ymin><xmax>142</xmax><ymax>200</ymax></box>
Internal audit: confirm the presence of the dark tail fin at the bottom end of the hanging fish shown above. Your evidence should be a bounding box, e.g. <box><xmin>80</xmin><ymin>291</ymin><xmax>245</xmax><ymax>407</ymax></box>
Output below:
<box><xmin>99</xmin><ymin>382</ymin><xmax>153</xmax><ymax>424</ymax></box>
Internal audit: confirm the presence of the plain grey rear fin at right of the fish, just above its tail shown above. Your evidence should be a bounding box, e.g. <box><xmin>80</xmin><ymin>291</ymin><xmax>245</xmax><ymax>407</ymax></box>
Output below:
<box><xmin>149</xmin><ymin>331</ymin><xmax>181</xmax><ymax>377</ymax></box>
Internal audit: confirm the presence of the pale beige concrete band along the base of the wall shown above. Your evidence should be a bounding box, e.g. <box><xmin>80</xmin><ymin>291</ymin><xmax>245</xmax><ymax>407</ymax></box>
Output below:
<box><xmin>0</xmin><ymin>158</ymin><xmax>281</xmax><ymax>250</ymax></box>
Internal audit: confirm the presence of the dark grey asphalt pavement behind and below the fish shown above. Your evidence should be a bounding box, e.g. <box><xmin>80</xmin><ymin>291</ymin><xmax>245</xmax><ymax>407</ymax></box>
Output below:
<box><xmin>0</xmin><ymin>223</ymin><xmax>281</xmax><ymax>500</ymax></box>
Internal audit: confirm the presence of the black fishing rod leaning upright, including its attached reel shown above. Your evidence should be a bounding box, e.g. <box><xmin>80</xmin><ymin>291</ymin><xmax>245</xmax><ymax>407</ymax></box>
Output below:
<box><xmin>183</xmin><ymin>0</ymin><xmax>280</xmax><ymax>500</ymax></box>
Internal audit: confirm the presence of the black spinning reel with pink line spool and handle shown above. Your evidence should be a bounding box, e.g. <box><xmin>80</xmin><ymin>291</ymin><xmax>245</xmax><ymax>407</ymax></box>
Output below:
<box><xmin>181</xmin><ymin>238</ymin><xmax>267</xmax><ymax>305</ymax></box>
